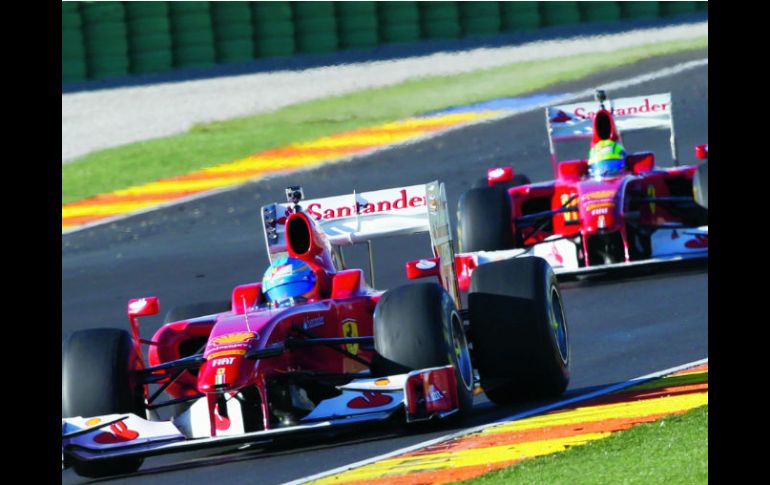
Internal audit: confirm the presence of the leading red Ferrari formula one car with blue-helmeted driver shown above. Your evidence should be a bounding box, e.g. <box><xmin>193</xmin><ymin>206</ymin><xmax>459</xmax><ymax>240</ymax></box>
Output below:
<box><xmin>62</xmin><ymin>182</ymin><xmax>570</xmax><ymax>476</ymax></box>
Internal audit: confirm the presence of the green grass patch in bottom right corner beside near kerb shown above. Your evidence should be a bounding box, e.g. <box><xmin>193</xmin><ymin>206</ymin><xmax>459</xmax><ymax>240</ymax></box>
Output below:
<box><xmin>450</xmin><ymin>406</ymin><xmax>708</xmax><ymax>485</ymax></box>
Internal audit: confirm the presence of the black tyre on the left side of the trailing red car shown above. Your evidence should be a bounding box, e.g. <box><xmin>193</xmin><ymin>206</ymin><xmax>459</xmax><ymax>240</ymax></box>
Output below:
<box><xmin>457</xmin><ymin>186</ymin><xmax>514</xmax><ymax>253</ymax></box>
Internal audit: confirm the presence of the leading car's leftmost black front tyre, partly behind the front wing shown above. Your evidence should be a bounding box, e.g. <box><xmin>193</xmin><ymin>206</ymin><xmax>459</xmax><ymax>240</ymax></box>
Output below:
<box><xmin>62</xmin><ymin>328</ymin><xmax>146</xmax><ymax>477</ymax></box>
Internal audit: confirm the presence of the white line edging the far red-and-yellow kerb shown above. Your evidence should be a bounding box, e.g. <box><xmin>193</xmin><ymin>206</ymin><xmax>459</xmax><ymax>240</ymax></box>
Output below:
<box><xmin>62</xmin><ymin>58</ymin><xmax>708</xmax><ymax>235</ymax></box>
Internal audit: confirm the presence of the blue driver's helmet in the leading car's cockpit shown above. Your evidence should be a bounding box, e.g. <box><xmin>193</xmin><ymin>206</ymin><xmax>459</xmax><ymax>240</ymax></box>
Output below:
<box><xmin>262</xmin><ymin>257</ymin><xmax>318</xmax><ymax>306</ymax></box>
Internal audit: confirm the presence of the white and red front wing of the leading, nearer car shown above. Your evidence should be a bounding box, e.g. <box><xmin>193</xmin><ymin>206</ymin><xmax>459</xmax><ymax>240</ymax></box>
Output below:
<box><xmin>62</xmin><ymin>365</ymin><xmax>458</xmax><ymax>464</ymax></box>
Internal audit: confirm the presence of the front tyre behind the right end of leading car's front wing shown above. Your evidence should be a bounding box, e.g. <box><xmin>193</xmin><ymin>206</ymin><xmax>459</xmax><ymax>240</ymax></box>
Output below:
<box><xmin>372</xmin><ymin>283</ymin><xmax>473</xmax><ymax>418</ymax></box>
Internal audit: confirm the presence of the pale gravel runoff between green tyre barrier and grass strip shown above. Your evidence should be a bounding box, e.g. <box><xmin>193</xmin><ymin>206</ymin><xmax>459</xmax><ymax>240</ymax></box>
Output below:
<box><xmin>62</xmin><ymin>22</ymin><xmax>708</xmax><ymax>164</ymax></box>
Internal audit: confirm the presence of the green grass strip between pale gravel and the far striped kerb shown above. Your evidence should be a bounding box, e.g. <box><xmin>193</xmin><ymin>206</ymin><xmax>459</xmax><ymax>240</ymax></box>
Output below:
<box><xmin>62</xmin><ymin>36</ymin><xmax>708</xmax><ymax>204</ymax></box>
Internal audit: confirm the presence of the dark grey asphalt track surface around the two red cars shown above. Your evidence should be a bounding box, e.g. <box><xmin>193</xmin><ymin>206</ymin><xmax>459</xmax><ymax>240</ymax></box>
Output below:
<box><xmin>62</xmin><ymin>51</ymin><xmax>708</xmax><ymax>484</ymax></box>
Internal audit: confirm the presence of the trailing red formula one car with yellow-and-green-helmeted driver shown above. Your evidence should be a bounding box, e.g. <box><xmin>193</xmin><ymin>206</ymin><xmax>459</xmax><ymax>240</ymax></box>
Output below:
<box><xmin>457</xmin><ymin>91</ymin><xmax>708</xmax><ymax>284</ymax></box>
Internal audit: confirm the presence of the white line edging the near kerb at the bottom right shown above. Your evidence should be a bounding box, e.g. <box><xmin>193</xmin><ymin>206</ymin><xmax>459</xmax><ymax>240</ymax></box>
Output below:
<box><xmin>283</xmin><ymin>358</ymin><xmax>708</xmax><ymax>485</ymax></box>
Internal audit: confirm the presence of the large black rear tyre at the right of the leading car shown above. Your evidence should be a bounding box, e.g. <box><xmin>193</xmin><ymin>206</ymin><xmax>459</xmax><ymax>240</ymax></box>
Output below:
<box><xmin>468</xmin><ymin>257</ymin><xmax>570</xmax><ymax>404</ymax></box>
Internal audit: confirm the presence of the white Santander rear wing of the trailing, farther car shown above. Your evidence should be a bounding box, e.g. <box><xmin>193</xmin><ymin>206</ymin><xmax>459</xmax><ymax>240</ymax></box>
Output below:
<box><xmin>545</xmin><ymin>93</ymin><xmax>678</xmax><ymax>168</ymax></box>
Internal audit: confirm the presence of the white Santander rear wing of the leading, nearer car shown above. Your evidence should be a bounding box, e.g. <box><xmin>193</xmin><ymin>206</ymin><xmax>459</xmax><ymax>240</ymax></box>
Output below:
<box><xmin>262</xmin><ymin>182</ymin><xmax>460</xmax><ymax>307</ymax></box>
